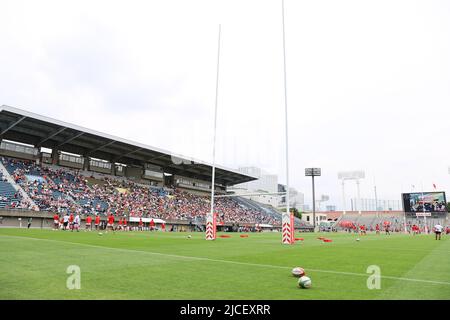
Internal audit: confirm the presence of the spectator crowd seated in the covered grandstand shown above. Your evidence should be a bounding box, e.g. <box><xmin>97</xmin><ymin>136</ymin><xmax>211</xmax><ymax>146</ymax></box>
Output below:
<box><xmin>2</xmin><ymin>158</ymin><xmax>281</xmax><ymax>225</ymax></box>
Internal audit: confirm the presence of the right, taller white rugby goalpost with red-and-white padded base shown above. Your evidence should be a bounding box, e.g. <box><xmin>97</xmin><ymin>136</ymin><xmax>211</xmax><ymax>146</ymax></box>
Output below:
<box><xmin>281</xmin><ymin>0</ymin><xmax>294</xmax><ymax>244</ymax></box>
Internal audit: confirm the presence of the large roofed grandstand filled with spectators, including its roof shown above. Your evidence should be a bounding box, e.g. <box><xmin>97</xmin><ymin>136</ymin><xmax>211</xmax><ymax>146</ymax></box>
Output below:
<box><xmin>0</xmin><ymin>106</ymin><xmax>311</xmax><ymax>231</ymax></box>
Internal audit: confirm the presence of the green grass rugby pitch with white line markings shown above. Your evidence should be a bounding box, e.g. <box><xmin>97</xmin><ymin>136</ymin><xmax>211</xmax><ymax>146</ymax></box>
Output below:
<box><xmin>0</xmin><ymin>228</ymin><xmax>450</xmax><ymax>300</ymax></box>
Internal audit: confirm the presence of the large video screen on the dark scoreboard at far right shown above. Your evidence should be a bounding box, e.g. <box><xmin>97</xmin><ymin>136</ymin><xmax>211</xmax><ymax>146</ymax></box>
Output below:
<box><xmin>402</xmin><ymin>192</ymin><xmax>447</xmax><ymax>213</ymax></box>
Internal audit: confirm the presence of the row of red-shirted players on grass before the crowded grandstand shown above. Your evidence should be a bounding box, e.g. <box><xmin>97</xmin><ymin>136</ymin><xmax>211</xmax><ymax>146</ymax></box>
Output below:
<box><xmin>53</xmin><ymin>213</ymin><xmax>166</xmax><ymax>232</ymax></box>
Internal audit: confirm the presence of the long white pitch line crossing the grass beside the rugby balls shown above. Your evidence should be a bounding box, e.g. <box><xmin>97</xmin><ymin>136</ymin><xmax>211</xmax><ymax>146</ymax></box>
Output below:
<box><xmin>0</xmin><ymin>235</ymin><xmax>450</xmax><ymax>286</ymax></box>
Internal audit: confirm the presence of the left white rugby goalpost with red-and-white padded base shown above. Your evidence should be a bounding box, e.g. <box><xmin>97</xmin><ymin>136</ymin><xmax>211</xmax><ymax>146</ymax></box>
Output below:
<box><xmin>206</xmin><ymin>24</ymin><xmax>221</xmax><ymax>240</ymax></box>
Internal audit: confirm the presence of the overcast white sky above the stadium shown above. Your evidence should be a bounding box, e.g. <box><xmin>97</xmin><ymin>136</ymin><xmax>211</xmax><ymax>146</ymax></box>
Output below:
<box><xmin>0</xmin><ymin>0</ymin><xmax>450</xmax><ymax>207</ymax></box>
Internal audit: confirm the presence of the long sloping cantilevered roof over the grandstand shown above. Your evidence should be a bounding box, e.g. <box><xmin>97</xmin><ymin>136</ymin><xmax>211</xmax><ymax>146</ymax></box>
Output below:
<box><xmin>0</xmin><ymin>105</ymin><xmax>257</xmax><ymax>186</ymax></box>
